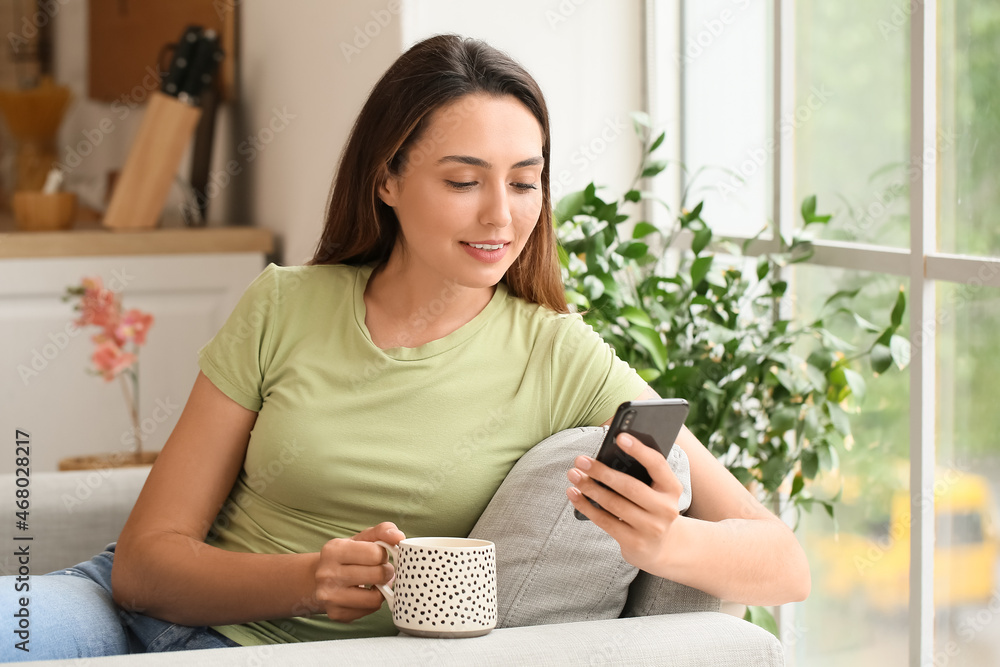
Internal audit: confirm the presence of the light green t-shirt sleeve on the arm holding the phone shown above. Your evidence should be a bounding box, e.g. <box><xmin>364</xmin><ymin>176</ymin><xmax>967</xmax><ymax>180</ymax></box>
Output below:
<box><xmin>551</xmin><ymin>315</ymin><xmax>646</xmax><ymax>432</ymax></box>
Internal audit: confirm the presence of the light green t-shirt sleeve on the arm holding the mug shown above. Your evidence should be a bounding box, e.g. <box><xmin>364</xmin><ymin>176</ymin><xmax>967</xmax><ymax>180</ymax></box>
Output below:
<box><xmin>198</xmin><ymin>264</ymin><xmax>280</xmax><ymax>412</ymax></box>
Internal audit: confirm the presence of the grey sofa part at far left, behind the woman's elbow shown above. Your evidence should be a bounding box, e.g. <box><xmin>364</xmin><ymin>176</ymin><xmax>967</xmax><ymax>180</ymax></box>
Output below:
<box><xmin>0</xmin><ymin>467</ymin><xmax>149</xmax><ymax>574</ymax></box>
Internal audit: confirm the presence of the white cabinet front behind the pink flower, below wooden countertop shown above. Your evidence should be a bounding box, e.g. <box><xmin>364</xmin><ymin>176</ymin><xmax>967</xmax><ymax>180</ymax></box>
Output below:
<box><xmin>0</xmin><ymin>252</ymin><xmax>265</xmax><ymax>473</ymax></box>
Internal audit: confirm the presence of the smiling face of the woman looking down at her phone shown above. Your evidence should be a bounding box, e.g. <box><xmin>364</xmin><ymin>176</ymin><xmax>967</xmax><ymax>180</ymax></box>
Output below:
<box><xmin>379</xmin><ymin>95</ymin><xmax>544</xmax><ymax>287</ymax></box>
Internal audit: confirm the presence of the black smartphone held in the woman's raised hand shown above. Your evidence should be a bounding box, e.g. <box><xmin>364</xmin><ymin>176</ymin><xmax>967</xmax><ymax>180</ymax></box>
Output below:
<box><xmin>573</xmin><ymin>398</ymin><xmax>688</xmax><ymax>521</ymax></box>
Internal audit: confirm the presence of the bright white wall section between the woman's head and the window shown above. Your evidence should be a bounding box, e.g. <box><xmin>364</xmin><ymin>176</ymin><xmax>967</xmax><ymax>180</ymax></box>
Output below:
<box><xmin>403</xmin><ymin>0</ymin><xmax>643</xmax><ymax>206</ymax></box>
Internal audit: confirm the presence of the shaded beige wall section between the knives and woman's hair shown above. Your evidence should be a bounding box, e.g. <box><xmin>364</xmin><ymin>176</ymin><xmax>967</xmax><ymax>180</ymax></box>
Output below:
<box><xmin>237</xmin><ymin>0</ymin><xmax>401</xmax><ymax>264</ymax></box>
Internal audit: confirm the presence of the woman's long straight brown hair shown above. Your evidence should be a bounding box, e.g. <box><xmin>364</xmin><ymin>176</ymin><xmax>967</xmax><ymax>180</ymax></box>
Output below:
<box><xmin>309</xmin><ymin>35</ymin><xmax>568</xmax><ymax>313</ymax></box>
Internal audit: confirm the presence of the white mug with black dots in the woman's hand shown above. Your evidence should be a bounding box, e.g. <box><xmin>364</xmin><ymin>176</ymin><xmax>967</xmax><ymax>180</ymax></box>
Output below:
<box><xmin>376</xmin><ymin>537</ymin><xmax>497</xmax><ymax>637</ymax></box>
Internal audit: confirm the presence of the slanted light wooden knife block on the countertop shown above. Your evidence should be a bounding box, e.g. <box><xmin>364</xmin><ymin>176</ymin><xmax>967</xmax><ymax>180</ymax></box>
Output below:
<box><xmin>103</xmin><ymin>91</ymin><xmax>201</xmax><ymax>229</ymax></box>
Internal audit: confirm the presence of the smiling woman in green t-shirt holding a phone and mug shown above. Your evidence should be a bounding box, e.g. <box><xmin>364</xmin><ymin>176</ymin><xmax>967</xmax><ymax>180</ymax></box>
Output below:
<box><xmin>1</xmin><ymin>36</ymin><xmax>809</xmax><ymax>659</ymax></box>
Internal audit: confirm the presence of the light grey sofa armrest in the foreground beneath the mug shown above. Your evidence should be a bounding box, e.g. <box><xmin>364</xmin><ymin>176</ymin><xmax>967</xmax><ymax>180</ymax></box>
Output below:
<box><xmin>41</xmin><ymin>612</ymin><xmax>784</xmax><ymax>667</ymax></box>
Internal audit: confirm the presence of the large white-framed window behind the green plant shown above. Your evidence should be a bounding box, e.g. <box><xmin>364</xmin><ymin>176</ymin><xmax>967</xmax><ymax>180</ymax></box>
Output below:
<box><xmin>646</xmin><ymin>0</ymin><xmax>1000</xmax><ymax>667</ymax></box>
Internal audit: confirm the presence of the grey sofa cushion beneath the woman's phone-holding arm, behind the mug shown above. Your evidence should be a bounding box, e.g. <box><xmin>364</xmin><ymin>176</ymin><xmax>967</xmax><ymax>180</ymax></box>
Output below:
<box><xmin>469</xmin><ymin>427</ymin><xmax>691</xmax><ymax>628</ymax></box>
